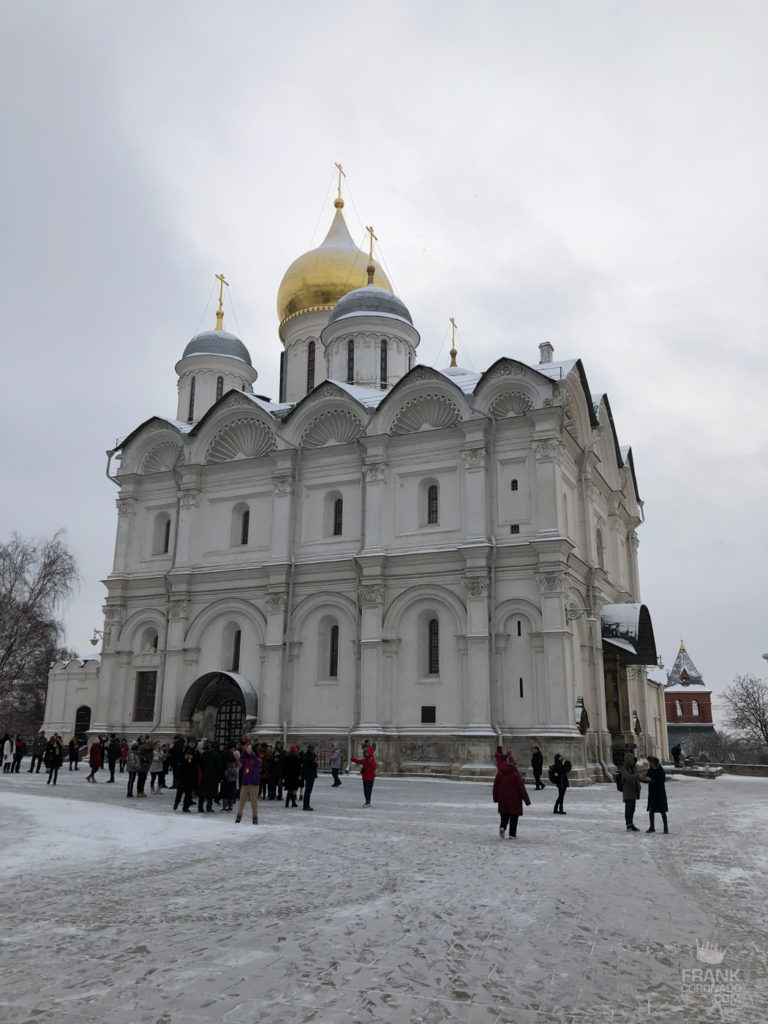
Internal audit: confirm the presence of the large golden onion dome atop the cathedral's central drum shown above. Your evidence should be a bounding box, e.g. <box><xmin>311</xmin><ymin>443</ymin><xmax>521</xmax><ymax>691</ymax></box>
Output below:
<box><xmin>278</xmin><ymin>198</ymin><xmax>392</xmax><ymax>327</ymax></box>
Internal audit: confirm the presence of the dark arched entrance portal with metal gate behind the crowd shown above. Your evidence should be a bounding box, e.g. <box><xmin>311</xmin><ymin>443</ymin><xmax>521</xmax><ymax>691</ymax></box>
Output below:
<box><xmin>179</xmin><ymin>672</ymin><xmax>258</xmax><ymax>743</ymax></box>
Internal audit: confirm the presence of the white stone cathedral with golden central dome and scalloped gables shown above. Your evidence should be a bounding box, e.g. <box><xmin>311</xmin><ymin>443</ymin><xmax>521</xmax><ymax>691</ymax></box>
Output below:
<box><xmin>44</xmin><ymin>190</ymin><xmax>667</xmax><ymax>781</ymax></box>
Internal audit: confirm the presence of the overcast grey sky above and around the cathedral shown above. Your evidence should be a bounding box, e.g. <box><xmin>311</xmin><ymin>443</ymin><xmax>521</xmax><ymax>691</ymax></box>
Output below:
<box><xmin>0</xmin><ymin>0</ymin><xmax>768</xmax><ymax>712</ymax></box>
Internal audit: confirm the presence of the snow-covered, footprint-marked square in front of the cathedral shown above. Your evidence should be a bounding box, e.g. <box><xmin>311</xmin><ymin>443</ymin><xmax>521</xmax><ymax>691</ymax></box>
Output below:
<box><xmin>0</xmin><ymin>763</ymin><xmax>768</xmax><ymax>1024</ymax></box>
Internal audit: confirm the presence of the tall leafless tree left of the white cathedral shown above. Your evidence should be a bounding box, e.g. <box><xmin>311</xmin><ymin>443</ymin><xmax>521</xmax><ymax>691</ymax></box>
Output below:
<box><xmin>0</xmin><ymin>530</ymin><xmax>80</xmax><ymax>730</ymax></box>
